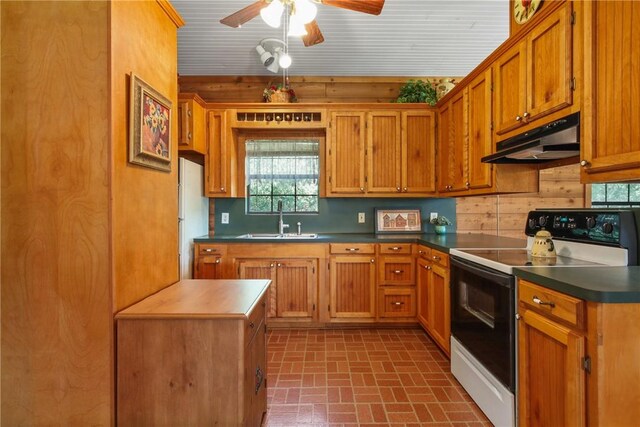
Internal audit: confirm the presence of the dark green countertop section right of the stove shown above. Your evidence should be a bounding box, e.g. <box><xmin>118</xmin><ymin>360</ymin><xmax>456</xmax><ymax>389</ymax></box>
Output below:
<box><xmin>514</xmin><ymin>266</ymin><xmax>640</xmax><ymax>303</ymax></box>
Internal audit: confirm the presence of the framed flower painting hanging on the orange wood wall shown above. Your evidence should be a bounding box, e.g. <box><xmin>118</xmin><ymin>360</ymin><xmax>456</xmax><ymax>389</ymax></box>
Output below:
<box><xmin>129</xmin><ymin>72</ymin><xmax>173</xmax><ymax>172</ymax></box>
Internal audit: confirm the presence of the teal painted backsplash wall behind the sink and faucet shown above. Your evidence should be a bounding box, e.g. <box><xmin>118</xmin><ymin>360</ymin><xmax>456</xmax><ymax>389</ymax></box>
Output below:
<box><xmin>215</xmin><ymin>198</ymin><xmax>456</xmax><ymax>235</ymax></box>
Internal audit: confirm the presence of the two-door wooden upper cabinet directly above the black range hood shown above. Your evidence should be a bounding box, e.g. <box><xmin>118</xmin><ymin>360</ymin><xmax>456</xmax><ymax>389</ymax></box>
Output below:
<box><xmin>494</xmin><ymin>2</ymin><xmax>573</xmax><ymax>139</ymax></box>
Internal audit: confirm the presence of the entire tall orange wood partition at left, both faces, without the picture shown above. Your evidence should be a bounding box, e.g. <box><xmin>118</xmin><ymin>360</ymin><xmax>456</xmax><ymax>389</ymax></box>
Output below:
<box><xmin>0</xmin><ymin>0</ymin><xmax>180</xmax><ymax>426</ymax></box>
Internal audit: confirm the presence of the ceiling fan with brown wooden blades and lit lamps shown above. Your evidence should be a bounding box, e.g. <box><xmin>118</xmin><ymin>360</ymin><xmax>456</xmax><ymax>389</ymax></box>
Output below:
<box><xmin>220</xmin><ymin>0</ymin><xmax>385</xmax><ymax>46</ymax></box>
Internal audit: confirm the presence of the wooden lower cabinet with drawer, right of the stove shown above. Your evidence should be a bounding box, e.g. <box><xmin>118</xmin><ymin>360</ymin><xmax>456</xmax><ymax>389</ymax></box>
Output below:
<box><xmin>518</xmin><ymin>279</ymin><xmax>640</xmax><ymax>426</ymax></box>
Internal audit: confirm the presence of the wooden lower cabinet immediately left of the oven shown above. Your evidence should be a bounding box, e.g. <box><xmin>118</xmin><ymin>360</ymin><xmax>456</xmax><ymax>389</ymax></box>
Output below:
<box><xmin>417</xmin><ymin>246</ymin><xmax>451</xmax><ymax>355</ymax></box>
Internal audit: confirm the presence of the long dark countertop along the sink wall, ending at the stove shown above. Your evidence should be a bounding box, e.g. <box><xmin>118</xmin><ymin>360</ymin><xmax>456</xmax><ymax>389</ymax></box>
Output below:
<box><xmin>193</xmin><ymin>233</ymin><xmax>527</xmax><ymax>253</ymax></box>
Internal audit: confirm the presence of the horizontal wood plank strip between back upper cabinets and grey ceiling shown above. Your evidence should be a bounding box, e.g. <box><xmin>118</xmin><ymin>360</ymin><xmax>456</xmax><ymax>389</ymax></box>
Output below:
<box><xmin>178</xmin><ymin>75</ymin><xmax>461</xmax><ymax>103</ymax></box>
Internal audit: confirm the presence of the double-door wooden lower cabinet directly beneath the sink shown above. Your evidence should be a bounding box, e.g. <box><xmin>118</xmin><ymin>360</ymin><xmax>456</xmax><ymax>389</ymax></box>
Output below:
<box><xmin>236</xmin><ymin>259</ymin><xmax>318</xmax><ymax>320</ymax></box>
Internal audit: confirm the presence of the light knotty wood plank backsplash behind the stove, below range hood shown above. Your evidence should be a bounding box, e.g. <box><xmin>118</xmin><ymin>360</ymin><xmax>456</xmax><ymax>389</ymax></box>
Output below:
<box><xmin>456</xmin><ymin>165</ymin><xmax>588</xmax><ymax>238</ymax></box>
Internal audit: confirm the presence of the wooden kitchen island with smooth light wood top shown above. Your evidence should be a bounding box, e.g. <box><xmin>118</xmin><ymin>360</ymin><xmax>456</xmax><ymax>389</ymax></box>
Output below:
<box><xmin>115</xmin><ymin>280</ymin><xmax>271</xmax><ymax>426</ymax></box>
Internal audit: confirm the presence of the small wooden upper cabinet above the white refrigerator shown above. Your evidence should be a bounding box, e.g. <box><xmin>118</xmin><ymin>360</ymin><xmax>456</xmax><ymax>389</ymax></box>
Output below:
<box><xmin>178</xmin><ymin>94</ymin><xmax>207</xmax><ymax>155</ymax></box>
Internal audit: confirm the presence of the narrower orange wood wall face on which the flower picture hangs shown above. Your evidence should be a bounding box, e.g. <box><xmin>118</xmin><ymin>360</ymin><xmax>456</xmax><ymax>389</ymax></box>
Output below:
<box><xmin>111</xmin><ymin>1</ymin><xmax>179</xmax><ymax>313</ymax></box>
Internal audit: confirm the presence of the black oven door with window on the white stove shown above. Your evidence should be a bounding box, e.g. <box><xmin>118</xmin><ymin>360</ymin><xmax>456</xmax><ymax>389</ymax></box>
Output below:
<box><xmin>451</xmin><ymin>256</ymin><xmax>515</xmax><ymax>392</ymax></box>
